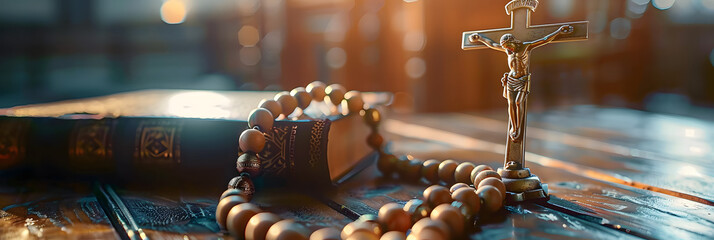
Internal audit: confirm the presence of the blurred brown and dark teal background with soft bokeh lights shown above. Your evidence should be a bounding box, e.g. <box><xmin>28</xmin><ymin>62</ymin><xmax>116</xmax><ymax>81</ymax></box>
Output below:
<box><xmin>0</xmin><ymin>0</ymin><xmax>714</xmax><ymax>118</ymax></box>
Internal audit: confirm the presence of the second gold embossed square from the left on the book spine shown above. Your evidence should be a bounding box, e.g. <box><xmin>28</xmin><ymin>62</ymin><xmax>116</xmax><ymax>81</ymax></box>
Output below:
<box><xmin>69</xmin><ymin>120</ymin><xmax>113</xmax><ymax>172</ymax></box>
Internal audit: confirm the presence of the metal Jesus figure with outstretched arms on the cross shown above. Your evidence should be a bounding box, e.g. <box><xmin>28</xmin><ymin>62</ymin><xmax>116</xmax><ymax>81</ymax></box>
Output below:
<box><xmin>469</xmin><ymin>25</ymin><xmax>573</xmax><ymax>141</ymax></box>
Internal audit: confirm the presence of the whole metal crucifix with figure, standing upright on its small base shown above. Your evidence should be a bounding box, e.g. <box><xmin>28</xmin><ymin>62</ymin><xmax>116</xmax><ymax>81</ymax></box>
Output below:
<box><xmin>461</xmin><ymin>0</ymin><xmax>588</xmax><ymax>204</ymax></box>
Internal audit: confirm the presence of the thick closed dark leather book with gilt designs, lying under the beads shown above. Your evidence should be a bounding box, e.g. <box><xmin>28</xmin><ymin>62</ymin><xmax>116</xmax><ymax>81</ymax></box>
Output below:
<box><xmin>0</xmin><ymin>90</ymin><xmax>390</xmax><ymax>190</ymax></box>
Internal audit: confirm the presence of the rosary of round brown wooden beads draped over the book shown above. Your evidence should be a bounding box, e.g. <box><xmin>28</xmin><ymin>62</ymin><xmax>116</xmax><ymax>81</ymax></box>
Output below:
<box><xmin>211</xmin><ymin>81</ymin><xmax>506</xmax><ymax>240</ymax></box>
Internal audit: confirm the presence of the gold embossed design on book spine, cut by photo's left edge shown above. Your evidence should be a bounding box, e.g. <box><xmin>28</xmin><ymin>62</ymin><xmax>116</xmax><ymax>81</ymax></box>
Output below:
<box><xmin>0</xmin><ymin>119</ymin><xmax>29</xmax><ymax>169</ymax></box>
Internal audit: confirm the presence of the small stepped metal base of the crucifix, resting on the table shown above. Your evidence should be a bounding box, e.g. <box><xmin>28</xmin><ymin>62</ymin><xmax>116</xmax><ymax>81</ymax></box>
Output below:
<box><xmin>498</xmin><ymin>168</ymin><xmax>550</xmax><ymax>205</ymax></box>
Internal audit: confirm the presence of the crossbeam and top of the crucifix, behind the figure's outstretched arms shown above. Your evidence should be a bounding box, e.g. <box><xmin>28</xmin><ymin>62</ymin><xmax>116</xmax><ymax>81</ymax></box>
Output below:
<box><xmin>461</xmin><ymin>0</ymin><xmax>588</xmax><ymax>50</ymax></box>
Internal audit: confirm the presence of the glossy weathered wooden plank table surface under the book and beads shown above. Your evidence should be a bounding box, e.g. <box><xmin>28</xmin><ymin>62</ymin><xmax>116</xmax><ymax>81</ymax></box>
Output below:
<box><xmin>0</xmin><ymin>106</ymin><xmax>714</xmax><ymax>239</ymax></box>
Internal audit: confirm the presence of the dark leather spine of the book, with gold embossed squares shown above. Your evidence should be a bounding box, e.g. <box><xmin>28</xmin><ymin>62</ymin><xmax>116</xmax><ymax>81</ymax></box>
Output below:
<box><xmin>0</xmin><ymin>117</ymin><xmax>331</xmax><ymax>190</ymax></box>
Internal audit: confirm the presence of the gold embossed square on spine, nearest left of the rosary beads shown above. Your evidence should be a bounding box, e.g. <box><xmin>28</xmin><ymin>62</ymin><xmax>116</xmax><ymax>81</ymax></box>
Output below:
<box><xmin>134</xmin><ymin>121</ymin><xmax>181</xmax><ymax>166</ymax></box>
